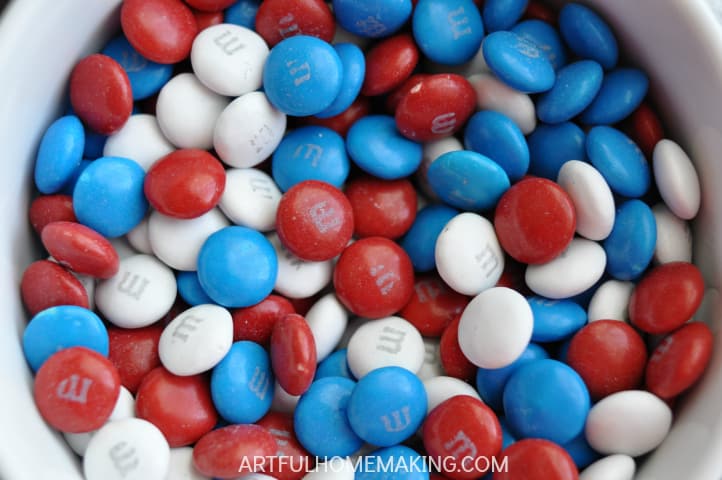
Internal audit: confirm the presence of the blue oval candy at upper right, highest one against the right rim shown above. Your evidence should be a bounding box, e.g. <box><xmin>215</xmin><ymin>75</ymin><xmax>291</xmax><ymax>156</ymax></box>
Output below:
<box><xmin>559</xmin><ymin>3</ymin><xmax>619</xmax><ymax>70</ymax></box>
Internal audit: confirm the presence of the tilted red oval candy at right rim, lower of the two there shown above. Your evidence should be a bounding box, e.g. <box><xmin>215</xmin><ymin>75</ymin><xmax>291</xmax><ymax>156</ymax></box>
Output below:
<box><xmin>646</xmin><ymin>322</ymin><xmax>714</xmax><ymax>399</ymax></box>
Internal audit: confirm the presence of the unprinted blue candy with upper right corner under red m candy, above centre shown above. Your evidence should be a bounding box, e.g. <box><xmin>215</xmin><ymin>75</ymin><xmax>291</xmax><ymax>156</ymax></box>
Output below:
<box><xmin>346</xmin><ymin>115</ymin><xmax>422</xmax><ymax>180</ymax></box>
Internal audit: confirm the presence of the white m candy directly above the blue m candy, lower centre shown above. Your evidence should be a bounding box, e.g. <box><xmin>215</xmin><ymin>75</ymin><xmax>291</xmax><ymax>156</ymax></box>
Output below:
<box><xmin>346</xmin><ymin>317</ymin><xmax>424</xmax><ymax>378</ymax></box>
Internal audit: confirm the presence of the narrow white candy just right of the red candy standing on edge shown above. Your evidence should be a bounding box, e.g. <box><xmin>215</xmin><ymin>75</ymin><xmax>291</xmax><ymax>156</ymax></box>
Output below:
<box><xmin>306</xmin><ymin>293</ymin><xmax>348</xmax><ymax>362</ymax></box>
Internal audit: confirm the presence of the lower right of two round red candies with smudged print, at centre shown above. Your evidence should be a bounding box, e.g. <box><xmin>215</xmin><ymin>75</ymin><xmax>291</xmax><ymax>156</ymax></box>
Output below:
<box><xmin>333</xmin><ymin>237</ymin><xmax>414</xmax><ymax>318</ymax></box>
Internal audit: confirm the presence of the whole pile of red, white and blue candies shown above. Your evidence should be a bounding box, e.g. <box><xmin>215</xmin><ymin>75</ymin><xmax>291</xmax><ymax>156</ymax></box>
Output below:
<box><xmin>21</xmin><ymin>0</ymin><xmax>712</xmax><ymax>480</ymax></box>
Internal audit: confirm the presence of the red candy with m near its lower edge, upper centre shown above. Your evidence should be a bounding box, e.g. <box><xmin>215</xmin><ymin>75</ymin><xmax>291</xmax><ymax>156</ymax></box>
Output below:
<box><xmin>395</xmin><ymin>73</ymin><xmax>476</xmax><ymax>142</ymax></box>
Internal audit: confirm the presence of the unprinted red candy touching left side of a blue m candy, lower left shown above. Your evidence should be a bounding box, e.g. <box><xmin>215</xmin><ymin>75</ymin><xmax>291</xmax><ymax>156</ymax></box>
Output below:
<box><xmin>135</xmin><ymin>367</ymin><xmax>218</xmax><ymax>447</ymax></box>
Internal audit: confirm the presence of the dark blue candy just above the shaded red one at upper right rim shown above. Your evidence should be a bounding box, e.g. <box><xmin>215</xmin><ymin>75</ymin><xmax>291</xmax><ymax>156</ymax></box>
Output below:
<box><xmin>581</xmin><ymin>68</ymin><xmax>649</xmax><ymax>125</ymax></box>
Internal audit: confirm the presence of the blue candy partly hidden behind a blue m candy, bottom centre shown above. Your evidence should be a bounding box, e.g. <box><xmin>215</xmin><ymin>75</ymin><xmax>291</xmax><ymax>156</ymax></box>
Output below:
<box><xmin>293</xmin><ymin>377</ymin><xmax>364</xmax><ymax>457</ymax></box>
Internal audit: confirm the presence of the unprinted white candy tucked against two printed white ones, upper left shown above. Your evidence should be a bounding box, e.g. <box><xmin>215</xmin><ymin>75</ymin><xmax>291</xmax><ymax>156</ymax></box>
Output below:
<box><xmin>155</xmin><ymin>73</ymin><xmax>229</xmax><ymax>150</ymax></box>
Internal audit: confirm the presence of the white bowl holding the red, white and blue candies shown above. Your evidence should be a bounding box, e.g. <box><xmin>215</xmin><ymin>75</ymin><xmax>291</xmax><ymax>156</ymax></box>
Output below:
<box><xmin>0</xmin><ymin>0</ymin><xmax>722</xmax><ymax>480</ymax></box>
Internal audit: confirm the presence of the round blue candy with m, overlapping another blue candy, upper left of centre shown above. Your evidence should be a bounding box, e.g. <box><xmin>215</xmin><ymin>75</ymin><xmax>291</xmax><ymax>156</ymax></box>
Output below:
<box><xmin>263</xmin><ymin>35</ymin><xmax>343</xmax><ymax>116</ymax></box>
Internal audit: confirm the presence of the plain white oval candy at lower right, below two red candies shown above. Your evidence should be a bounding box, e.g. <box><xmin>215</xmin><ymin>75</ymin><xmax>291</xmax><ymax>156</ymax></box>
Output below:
<box><xmin>585</xmin><ymin>390</ymin><xmax>672</xmax><ymax>457</ymax></box>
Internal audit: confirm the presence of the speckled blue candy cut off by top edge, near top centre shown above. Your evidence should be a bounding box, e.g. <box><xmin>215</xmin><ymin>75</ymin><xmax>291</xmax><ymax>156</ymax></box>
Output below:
<box><xmin>333</xmin><ymin>0</ymin><xmax>410</xmax><ymax>38</ymax></box>
